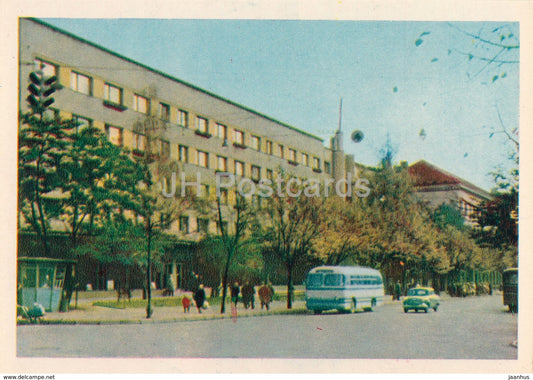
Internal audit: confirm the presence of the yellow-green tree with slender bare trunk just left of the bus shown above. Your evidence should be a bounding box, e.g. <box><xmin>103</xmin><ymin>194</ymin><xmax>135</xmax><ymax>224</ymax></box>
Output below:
<box><xmin>254</xmin><ymin>172</ymin><xmax>324</xmax><ymax>309</ymax></box>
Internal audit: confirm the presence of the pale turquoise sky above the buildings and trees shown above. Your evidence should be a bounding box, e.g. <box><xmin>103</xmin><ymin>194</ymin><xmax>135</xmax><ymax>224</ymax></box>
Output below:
<box><xmin>43</xmin><ymin>19</ymin><xmax>519</xmax><ymax>190</ymax></box>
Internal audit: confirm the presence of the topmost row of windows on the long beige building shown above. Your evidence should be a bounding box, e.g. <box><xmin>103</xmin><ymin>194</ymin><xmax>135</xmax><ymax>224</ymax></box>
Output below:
<box><xmin>35</xmin><ymin>59</ymin><xmax>330</xmax><ymax>173</ymax></box>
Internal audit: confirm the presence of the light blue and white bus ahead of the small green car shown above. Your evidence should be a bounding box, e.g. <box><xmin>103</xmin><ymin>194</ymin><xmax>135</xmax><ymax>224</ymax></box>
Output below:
<box><xmin>305</xmin><ymin>266</ymin><xmax>385</xmax><ymax>314</ymax></box>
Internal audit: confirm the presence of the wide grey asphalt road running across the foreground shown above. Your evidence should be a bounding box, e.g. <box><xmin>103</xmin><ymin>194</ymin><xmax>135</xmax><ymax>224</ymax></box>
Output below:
<box><xmin>17</xmin><ymin>295</ymin><xmax>517</xmax><ymax>359</ymax></box>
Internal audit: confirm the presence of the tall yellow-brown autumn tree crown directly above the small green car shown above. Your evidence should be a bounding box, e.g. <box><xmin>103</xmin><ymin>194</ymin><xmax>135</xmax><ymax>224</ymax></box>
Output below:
<box><xmin>363</xmin><ymin>165</ymin><xmax>449</xmax><ymax>281</ymax></box>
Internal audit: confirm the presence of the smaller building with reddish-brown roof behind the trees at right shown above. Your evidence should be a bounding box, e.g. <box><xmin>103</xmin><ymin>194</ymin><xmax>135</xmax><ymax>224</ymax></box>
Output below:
<box><xmin>408</xmin><ymin>160</ymin><xmax>492</xmax><ymax>226</ymax></box>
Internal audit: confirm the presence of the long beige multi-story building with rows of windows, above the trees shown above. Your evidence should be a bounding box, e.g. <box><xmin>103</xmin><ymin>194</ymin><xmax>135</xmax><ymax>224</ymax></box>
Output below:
<box><xmin>19</xmin><ymin>18</ymin><xmax>353</xmax><ymax>290</ymax></box>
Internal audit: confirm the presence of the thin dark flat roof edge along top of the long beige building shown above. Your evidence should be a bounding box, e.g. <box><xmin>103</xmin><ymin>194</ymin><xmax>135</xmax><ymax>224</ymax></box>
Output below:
<box><xmin>26</xmin><ymin>17</ymin><xmax>324</xmax><ymax>143</ymax></box>
